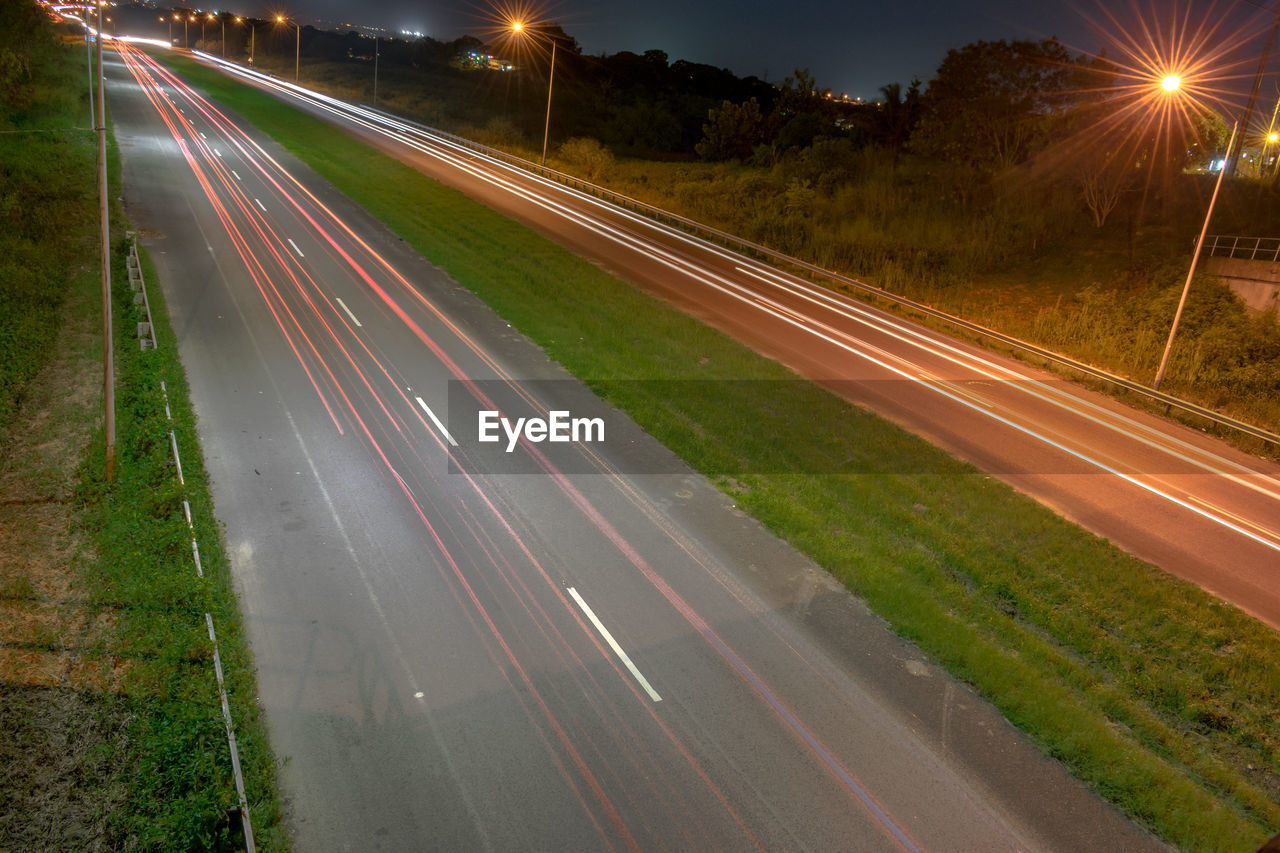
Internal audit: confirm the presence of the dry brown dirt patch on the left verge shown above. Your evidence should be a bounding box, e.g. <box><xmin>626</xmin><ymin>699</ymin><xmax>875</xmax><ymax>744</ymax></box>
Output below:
<box><xmin>0</xmin><ymin>286</ymin><xmax>131</xmax><ymax>850</ymax></box>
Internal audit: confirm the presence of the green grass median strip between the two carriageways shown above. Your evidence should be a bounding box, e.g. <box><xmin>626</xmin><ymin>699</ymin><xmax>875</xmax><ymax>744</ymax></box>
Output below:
<box><xmin>166</xmin><ymin>58</ymin><xmax>1280</xmax><ymax>850</ymax></box>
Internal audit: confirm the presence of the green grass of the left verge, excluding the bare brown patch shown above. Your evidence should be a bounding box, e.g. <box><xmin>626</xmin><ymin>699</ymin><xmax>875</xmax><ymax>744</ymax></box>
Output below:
<box><xmin>0</xmin><ymin>18</ymin><xmax>287</xmax><ymax>852</ymax></box>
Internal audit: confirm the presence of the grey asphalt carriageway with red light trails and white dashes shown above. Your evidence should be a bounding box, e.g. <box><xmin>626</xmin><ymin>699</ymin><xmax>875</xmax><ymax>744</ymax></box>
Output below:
<box><xmin>108</xmin><ymin>47</ymin><xmax>1162</xmax><ymax>852</ymax></box>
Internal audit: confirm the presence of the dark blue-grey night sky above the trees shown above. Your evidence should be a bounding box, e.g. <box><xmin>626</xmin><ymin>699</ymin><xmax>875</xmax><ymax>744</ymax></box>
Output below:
<box><xmin>220</xmin><ymin>0</ymin><xmax>1276</xmax><ymax>100</ymax></box>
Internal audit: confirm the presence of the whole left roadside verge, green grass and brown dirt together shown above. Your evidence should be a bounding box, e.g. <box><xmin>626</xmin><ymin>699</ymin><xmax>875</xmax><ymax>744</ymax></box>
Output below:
<box><xmin>0</xmin><ymin>21</ymin><xmax>287</xmax><ymax>850</ymax></box>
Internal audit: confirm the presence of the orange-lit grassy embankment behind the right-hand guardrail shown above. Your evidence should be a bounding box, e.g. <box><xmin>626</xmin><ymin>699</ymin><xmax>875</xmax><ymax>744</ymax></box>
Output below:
<box><xmin>235</xmin><ymin>56</ymin><xmax>1280</xmax><ymax>440</ymax></box>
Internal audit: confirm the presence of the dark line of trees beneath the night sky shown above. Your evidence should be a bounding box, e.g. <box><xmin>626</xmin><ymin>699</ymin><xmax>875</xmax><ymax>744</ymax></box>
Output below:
<box><xmin>127</xmin><ymin>4</ymin><xmax>1225</xmax><ymax>202</ymax></box>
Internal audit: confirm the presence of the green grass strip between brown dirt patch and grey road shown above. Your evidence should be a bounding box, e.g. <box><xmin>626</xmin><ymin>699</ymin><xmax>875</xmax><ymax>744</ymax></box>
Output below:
<box><xmin>77</xmin><ymin>235</ymin><xmax>288</xmax><ymax>850</ymax></box>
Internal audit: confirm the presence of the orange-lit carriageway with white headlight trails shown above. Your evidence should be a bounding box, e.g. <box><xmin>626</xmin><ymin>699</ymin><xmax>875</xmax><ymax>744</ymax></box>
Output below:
<box><xmin>185</xmin><ymin>58</ymin><xmax>1280</xmax><ymax>628</ymax></box>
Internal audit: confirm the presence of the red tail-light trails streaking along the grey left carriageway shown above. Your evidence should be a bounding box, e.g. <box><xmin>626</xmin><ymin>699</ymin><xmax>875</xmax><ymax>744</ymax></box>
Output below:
<box><xmin>122</xmin><ymin>47</ymin><xmax>918</xmax><ymax>850</ymax></box>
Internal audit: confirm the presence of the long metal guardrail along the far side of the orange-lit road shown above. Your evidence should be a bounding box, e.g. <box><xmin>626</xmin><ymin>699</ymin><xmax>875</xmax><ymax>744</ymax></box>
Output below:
<box><xmin>361</xmin><ymin>105</ymin><xmax>1280</xmax><ymax>444</ymax></box>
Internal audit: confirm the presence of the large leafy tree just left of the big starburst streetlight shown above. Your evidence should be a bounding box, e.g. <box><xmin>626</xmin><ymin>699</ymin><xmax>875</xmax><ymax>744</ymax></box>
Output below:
<box><xmin>911</xmin><ymin>38</ymin><xmax>1073</xmax><ymax>170</ymax></box>
